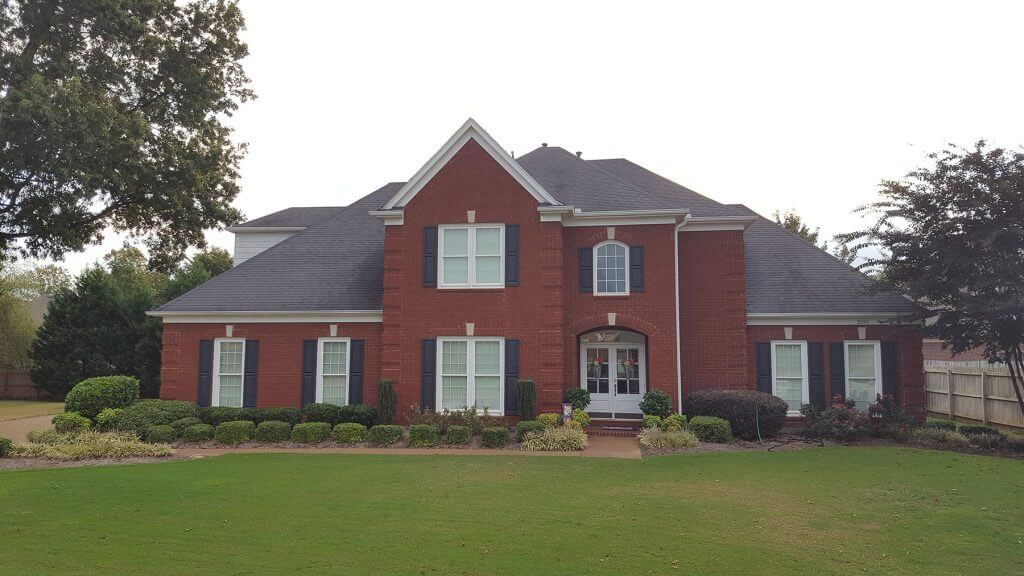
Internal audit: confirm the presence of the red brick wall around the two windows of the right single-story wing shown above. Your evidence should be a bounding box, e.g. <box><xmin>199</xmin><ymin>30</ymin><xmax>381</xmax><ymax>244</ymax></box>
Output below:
<box><xmin>746</xmin><ymin>326</ymin><xmax>925</xmax><ymax>410</ymax></box>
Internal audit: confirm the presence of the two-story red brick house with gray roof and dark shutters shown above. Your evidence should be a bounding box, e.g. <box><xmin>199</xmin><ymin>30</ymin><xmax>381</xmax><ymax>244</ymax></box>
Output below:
<box><xmin>153</xmin><ymin>120</ymin><xmax>924</xmax><ymax>418</ymax></box>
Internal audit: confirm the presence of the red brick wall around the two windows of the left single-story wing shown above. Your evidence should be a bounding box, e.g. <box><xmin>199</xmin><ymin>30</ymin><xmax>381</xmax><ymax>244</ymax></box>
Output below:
<box><xmin>160</xmin><ymin>323</ymin><xmax>381</xmax><ymax>408</ymax></box>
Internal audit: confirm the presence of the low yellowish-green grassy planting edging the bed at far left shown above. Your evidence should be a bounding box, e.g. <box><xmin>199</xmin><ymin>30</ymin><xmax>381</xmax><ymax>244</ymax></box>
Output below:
<box><xmin>14</xmin><ymin>430</ymin><xmax>171</xmax><ymax>460</ymax></box>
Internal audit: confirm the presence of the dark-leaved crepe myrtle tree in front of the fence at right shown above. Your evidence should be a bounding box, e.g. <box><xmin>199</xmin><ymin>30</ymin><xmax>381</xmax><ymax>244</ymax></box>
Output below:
<box><xmin>844</xmin><ymin>140</ymin><xmax>1024</xmax><ymax>414</ymax></box>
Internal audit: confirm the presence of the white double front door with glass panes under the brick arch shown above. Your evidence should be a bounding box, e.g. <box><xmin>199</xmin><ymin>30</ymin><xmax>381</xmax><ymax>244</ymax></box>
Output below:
<box><xmin>580</xmin><ymin>342</ymin><xmax>647</xmax><ymax>418</ymax></box>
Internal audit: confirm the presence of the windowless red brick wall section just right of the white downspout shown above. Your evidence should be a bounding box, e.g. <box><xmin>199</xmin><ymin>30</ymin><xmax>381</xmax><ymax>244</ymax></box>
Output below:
<box><xmin>670</xmin><ymin>231</ymin><xmax>752</xmax><ymax>397</ymax></box>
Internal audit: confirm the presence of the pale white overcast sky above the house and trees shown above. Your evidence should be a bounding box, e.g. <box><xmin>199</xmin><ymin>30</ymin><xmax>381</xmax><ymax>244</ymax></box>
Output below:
<box><xmin>54</xmin><ymin>0</ymin><xmax>1024</xmax><ymax>272</ymax></box>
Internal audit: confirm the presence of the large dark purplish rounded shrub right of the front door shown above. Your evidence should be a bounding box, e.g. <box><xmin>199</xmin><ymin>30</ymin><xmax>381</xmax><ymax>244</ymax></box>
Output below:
<box><xmin>682</xmin><ymin>390</ymin><xmax>786</xmax><ymax>440</ymax></box>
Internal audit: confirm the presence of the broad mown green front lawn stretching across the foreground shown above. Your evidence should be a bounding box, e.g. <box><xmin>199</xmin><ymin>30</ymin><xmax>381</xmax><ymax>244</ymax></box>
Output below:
<box><xmin>0</xmin><ymin>447</ymin><xmax>1024</xmax><ymax>576</ymax></box>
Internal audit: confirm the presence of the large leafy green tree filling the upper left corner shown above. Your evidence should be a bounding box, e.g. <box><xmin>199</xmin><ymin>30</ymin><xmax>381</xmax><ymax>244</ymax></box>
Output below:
<box><xmin>0</xmin><ymin>0</ymin><xmax>252</xmax><ymax>271</ymax></box>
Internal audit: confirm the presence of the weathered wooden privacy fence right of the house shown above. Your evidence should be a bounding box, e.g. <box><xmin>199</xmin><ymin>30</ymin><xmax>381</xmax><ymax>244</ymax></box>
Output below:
<box><xmin>925</xmin><ymin>366</ymin><xmax>1024</xmax><ymax>427</ymax></box>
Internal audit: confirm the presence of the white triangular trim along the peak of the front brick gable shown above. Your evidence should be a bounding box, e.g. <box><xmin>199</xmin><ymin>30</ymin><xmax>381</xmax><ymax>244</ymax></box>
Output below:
<box><xmin>382</xmin><ymin>118</ymin><xmax>561</xmax><ymax>210</ymax></box>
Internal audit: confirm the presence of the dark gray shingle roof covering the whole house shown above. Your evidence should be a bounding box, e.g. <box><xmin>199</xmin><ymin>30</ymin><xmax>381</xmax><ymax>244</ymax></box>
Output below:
<box><xmin>159</xmin><ymin>147</ymin><xmax>916</xmax><ymax>314</ymax></box>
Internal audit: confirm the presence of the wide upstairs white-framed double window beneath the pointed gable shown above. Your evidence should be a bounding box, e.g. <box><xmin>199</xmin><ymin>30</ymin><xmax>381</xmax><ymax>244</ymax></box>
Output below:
<box><xmin>437</xmin><ymin>224</ymin><xmax>505</xmax><ymax>288</ymax></box>
